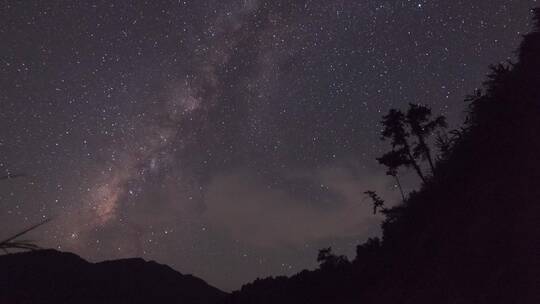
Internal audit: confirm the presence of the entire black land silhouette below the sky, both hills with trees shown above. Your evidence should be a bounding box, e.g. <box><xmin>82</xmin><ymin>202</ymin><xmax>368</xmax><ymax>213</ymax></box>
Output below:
<box><xmin>0</xmin><ymin>5</ymin><xmax>540</xmax><ymax>304</ymax></box>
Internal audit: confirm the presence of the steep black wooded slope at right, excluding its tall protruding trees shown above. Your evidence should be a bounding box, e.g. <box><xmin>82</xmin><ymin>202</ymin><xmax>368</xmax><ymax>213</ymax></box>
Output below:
<box><xmin>221</xmin><ymin>6</ymin><xmax>540</xmax><ymax>304</ymax></box>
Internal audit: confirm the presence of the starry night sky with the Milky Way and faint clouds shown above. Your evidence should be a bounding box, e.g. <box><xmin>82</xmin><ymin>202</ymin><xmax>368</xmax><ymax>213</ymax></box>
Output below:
<box><xmin>0</xmin><ymin>0</ymin><xmax>537</xmax><ymax>290</ymax></box>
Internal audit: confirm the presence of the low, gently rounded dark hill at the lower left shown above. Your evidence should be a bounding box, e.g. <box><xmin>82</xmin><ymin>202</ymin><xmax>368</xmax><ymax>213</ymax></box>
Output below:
<box><xmin>0</xmin><ymin>250</ymin><xmax>225</xmax><ymax>304</ymax></box>
